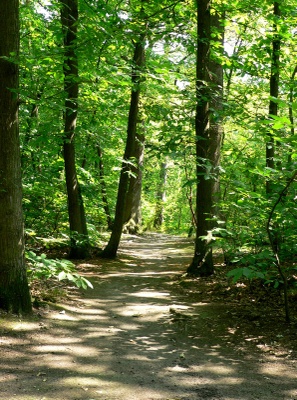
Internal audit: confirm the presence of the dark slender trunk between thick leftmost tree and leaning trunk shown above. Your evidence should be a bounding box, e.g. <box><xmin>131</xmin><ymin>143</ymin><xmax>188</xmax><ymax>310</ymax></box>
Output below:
<box><xmin>61</xmin><ymin>0</ymin><xmax>89</xmax><ymax>259</ymax></box>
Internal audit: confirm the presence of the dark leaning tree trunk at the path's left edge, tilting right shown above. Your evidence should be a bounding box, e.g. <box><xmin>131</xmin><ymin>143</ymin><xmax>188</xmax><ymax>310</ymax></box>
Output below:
<box><xmin>101</xmin><ymin>30</ymin><xmax>145</xmax><ymax>258</ymax></box>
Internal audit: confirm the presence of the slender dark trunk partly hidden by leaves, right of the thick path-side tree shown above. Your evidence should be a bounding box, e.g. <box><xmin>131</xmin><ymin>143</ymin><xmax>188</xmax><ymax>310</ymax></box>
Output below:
<box><xmin>266</xmin><ymin>1</ymin><xmax>281</xmax><ymax>195</ymax></box>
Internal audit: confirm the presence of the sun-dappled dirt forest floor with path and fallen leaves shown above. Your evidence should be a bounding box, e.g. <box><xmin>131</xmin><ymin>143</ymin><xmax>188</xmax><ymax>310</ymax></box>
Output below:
<box><xmin>0</xmin><ymin>234</ymin><xmax>297</xmax><ymax>400</ymax></box>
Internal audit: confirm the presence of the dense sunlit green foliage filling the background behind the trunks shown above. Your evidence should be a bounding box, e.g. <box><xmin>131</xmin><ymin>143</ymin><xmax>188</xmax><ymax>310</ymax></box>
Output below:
<box><xmin>19</xmin><ymin>0</ymin><xmax>297</xmax><ymax>294</ymax></box>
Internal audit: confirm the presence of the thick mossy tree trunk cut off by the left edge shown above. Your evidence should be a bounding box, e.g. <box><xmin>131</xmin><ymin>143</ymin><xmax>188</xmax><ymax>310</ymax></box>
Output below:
<box><xmin>0</xmin><ymin>0</ymin><xmax>32</xmax><ymax>314</ymax></box>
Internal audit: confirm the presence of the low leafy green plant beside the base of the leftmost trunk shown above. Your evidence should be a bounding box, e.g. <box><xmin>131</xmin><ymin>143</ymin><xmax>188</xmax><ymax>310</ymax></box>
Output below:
<box><xmin>26</xmin><ymin>250</ymin><xmax>93</xmax><ymax>289</ymax></box>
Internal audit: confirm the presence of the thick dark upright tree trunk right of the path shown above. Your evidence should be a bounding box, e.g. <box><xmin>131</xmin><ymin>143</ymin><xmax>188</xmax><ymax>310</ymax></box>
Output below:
<box><xmin>187</xmin><ymin>0</ymin><xmax>223</xmax><ymax>276</ymax></box>
